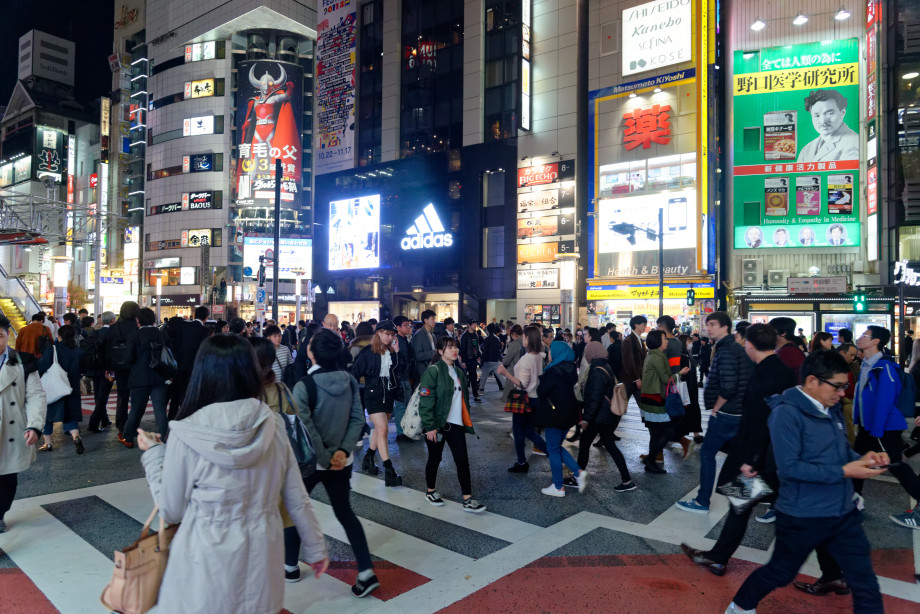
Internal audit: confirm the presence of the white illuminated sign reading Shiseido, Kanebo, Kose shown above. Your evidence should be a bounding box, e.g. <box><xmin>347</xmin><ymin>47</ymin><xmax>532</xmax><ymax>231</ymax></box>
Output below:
<box><xmin>623</xmin><ymin>0</ymin><xmax>693</xmax><ymax>76</ymax></box>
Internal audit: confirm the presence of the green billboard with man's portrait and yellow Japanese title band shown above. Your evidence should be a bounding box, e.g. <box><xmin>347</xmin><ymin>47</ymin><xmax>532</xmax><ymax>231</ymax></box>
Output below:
<box><xmin>732</xmin><ymin>38</ymin><xmax>861</xmax><ymax>249</ymax></box>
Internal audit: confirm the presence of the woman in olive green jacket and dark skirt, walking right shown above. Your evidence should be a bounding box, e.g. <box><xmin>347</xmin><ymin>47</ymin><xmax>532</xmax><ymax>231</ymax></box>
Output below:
<box><xmin>639</xmin><ymin>330</ymin><xmax>673</xmax><ymax>473</ymax></box>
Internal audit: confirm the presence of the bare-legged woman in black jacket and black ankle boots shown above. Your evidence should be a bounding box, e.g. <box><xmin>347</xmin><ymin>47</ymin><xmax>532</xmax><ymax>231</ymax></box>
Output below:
<box><xmin>351</xmin><ymin>320</ymin><xmax>402</xmax><ymax>486</ymax></box>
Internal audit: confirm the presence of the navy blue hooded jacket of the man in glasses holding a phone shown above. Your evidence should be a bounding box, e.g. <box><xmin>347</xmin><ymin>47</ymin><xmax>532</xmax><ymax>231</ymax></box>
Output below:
<box><xmin>767</xmin><ymin>388</ymin><xmax>859</xmax><ymax>518</ymax></box>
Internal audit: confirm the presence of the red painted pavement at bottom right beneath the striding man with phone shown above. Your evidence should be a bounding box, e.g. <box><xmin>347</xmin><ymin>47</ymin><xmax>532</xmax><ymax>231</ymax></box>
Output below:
<box><xmin>441</xmin><ymin>554</ymin><xmax>918</xmax><ymax>614</ymax></box>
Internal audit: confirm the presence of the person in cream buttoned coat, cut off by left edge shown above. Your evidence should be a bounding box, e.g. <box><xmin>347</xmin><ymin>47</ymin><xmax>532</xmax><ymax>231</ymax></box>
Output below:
<box><xmin>0</xmin><ymin>316</ymin><xmax>46</xmax><ymax>533</ymax></box>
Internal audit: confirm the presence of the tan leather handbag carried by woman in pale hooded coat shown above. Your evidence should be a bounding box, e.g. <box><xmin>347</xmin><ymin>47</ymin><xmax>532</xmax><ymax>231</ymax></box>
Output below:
<box><xmin>100</xmin><ymin>507</ymin><xmax>179</xmax><ymax>614</ymax></box>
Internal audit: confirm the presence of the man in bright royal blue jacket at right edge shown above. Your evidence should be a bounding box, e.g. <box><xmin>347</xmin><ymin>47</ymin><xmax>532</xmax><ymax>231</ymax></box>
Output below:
<box><xmin>853</xmin><ymin>326</ymin><xmax>920</xmax><ymax>529</ymax></box>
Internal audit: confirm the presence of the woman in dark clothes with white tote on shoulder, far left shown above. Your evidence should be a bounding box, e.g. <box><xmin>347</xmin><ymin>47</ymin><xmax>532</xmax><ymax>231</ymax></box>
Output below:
<box><xmin>38</xmin><ymin>324</ymin><xmax>85</xmax><ymax>454</ymax></box>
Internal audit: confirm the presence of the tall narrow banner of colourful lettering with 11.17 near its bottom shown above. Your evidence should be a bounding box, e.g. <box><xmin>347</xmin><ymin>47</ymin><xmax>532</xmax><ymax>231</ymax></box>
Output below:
<box><xmin>314</xmin><ymin>0</ymin><xmax>357</xmax><ymax>175</ymax></box>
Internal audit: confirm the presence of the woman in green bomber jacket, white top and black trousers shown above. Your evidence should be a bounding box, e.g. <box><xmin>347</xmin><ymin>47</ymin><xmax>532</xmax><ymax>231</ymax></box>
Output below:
<box><xmin>418</xmin><ymin>337</ymin><xmax>486</xmax><ymax>513</ymax></box>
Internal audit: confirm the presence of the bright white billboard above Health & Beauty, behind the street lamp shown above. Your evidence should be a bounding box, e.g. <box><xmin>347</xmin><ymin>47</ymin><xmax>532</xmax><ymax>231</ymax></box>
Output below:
<box><xmin>595</xmin><ymin>189</ymin><xmax>699</xmax><ymax>277</ymax></box>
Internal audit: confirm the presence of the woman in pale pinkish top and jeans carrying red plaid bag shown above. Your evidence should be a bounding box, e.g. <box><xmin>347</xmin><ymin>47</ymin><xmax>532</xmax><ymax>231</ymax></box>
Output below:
<box><xmin>498</xmin><ymin>326</ymin><xmax>546</xmax><ymax>473</ymax></box>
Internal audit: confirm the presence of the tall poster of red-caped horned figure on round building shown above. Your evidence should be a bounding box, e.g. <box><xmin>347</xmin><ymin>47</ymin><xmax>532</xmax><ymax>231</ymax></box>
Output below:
<box><xmin>235</xmin><ymin>60</ymin><xmax>303</xmax><ymax>207</ymax></box>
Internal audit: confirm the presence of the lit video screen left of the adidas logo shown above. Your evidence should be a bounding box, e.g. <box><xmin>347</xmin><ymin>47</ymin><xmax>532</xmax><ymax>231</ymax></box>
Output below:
<box><xmin>329</xmin><ymin>194</ymin><xmax>380</xmax><ymax>271</ymax></box>
